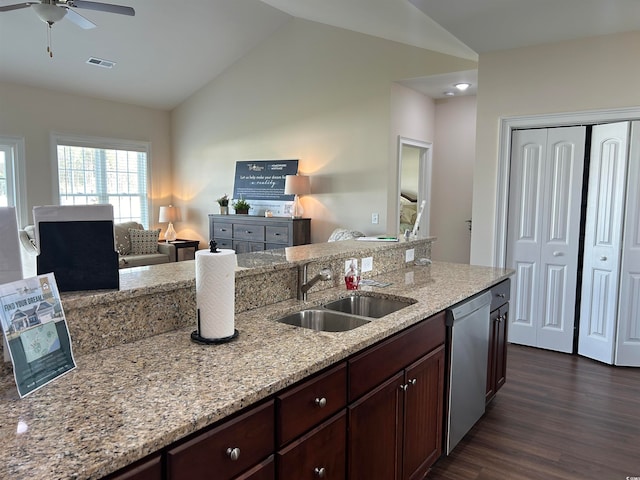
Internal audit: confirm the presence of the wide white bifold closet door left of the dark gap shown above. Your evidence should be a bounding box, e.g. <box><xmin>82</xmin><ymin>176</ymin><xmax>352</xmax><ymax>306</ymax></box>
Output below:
<box><xmin>507</xmin><ymin>127</ymin><xmax>586</xmax><ymax>352</ymax></box>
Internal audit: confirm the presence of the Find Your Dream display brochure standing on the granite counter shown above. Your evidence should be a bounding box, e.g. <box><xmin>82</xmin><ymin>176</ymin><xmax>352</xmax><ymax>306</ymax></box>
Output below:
<box><xmin>0</xmin><ymin>273</ymin><xmax>76</xmax><ymax>398</ymax></box>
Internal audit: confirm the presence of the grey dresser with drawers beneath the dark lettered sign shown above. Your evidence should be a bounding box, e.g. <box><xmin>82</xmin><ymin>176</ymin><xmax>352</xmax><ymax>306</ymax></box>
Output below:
<box><xmin>209</xmin><ymin>214</ymin><xmax>311</xmax><ymax>253</ymax></box>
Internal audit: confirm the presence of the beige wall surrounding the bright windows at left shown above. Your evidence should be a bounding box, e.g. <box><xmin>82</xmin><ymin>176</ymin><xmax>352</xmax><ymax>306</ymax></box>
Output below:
<box><xmin>0</xmin><ymin>83</ymin><xmax>171</xmax><ymax>226</ymax></box>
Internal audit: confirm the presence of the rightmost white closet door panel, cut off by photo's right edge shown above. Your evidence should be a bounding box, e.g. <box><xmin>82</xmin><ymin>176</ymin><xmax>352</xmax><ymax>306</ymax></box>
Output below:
<box><xmin>615</xmin><ymin>122</ymin><xmax>640</xmax><ymax>367</ymax></box>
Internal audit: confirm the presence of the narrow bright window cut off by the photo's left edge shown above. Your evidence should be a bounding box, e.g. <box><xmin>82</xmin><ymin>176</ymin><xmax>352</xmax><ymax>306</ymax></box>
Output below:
<box><xmin>0</xmin><ymin>136</ymin><xmax>26</xmax><ymax>221</ymax></box>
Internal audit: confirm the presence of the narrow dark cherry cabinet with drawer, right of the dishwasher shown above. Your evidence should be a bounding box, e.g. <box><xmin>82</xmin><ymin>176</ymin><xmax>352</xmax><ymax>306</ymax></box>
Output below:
<box><xmin>486</xmin><ymin>279</ymin><xmax>511</xmax><ymax>403</ymax></box>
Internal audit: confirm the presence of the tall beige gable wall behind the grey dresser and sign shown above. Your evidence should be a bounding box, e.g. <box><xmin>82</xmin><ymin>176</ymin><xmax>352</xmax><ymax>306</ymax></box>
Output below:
<box><xmin>172</xmin><ymin>19</ymin><xmax>475</xmax><ymax>242</ymax></box>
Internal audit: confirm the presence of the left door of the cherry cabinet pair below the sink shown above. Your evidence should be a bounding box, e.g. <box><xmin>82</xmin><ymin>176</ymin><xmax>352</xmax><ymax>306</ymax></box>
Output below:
<box><xmin>347</xmin><ymin>372</ymin><xmax>404</xmax><ymax>480</ymax></box>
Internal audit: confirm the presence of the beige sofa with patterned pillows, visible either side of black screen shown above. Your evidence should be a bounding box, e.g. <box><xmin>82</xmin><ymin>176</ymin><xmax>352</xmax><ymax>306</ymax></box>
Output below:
<box><xmin>18</xmin><ymin>222</ymin><xmax>176</xmax><ymax>272</ymax></box>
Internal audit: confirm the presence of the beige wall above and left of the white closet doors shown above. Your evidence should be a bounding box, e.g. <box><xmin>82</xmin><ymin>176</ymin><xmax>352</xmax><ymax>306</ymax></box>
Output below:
<box><xmin>471</xmin><ymin>32</ymin><xmax>640</xmax><ymax>265</ymax></box>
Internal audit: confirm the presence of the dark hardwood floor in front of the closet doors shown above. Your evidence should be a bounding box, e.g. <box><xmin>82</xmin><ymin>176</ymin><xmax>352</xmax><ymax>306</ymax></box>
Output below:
<box><xmin>427</xmin><ymin>345</ymin><xmax>640</xmax><ymax>480</ymax></box>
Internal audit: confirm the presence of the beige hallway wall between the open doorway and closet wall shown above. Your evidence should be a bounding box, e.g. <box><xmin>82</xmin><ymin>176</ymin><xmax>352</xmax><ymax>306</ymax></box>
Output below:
<box><xmin>430</xmin><ymin>95</ymin><xmax>476</xmax><ymax>263</ymax></box>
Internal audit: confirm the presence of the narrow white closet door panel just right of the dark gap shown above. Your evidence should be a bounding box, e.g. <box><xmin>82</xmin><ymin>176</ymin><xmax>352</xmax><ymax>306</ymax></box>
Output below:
<box><xmin>578</xmin><ymin>122</ymin><xmax>629</xmax><ymax>364</ymax></box>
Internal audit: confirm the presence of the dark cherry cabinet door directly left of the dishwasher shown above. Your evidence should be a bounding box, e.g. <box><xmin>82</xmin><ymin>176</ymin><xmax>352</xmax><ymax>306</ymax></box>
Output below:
<box><xmin>402</xmin><ymin>345</ymin><xmax>444</xmax><ymax>480</ymax></box>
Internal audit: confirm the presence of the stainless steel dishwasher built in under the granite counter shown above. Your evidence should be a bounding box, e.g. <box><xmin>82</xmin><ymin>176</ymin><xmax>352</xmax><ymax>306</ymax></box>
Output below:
<box><xmin>445</xmin><ymin>292</ymin><xmax>491</xmax><ymax>455</ymax></box>
